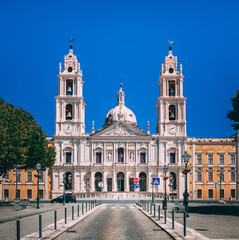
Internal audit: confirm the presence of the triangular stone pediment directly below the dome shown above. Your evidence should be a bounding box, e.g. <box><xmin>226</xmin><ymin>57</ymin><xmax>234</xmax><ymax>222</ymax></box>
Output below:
<box><xmin>92</xmin><ymin>122</ymin><xmax>149</xmax><ymax>137</ymax></box>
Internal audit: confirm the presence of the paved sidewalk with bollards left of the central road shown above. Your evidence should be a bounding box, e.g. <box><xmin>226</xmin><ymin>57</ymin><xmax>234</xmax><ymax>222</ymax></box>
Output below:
<box><xmin>0</xmin><ymin>203</ymin><xmax>99</xmax><ymax>240</ymax></box>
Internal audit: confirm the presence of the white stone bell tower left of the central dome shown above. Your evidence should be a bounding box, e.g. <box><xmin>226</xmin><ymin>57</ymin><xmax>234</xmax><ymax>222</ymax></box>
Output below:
<box><xmin>55</xmin><ymin>40</ymin><xmax>85</xmax><ymax>136</ymax></box>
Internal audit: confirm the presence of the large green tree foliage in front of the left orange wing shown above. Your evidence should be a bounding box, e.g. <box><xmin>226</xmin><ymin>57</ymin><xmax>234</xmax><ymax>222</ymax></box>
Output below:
<box><xmin>0</xmin><ymin>98</ymin><xmax>55</xmax><ymax>176</ymax></box>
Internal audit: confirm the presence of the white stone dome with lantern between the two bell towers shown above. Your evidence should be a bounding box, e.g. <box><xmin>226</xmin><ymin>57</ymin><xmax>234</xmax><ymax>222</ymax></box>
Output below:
<box><xmin>104</xmin><ymin>84</ymin><xmax>137</xmax><ymax>127</ymax></box>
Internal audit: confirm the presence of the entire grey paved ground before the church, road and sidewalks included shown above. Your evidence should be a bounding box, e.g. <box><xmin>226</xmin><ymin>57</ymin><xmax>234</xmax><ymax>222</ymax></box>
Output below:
<box><xmin>0</xmin><ymin>202</ymin><xmax>239</xmax><ymax>240</ymax></box>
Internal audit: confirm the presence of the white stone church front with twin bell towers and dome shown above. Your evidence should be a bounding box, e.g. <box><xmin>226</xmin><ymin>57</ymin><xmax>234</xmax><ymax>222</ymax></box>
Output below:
<box><xmin>51</xmin><ymin>46</ymin><xmax>186</xmax><ymax>199</ymax></box>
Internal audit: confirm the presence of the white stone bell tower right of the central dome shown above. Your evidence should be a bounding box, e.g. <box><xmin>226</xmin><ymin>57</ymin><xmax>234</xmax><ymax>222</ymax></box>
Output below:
<box><xmin>156</xmin><ymin>41</ymin><xmax>186</xmax><ymax>137</ymax></box>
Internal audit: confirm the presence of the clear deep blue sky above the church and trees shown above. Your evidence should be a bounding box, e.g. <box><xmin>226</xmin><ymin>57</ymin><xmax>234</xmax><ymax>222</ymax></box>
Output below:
<box><xmin>0</xmin><ymin>0</ymin><xmax>239</xmax><ymax>137</ymax></box>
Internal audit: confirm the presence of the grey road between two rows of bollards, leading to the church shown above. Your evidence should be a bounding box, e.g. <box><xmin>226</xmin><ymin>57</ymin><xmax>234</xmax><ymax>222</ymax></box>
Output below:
<box><xmin>57</xmin><ymin>204</ymin><xmax>171</xmax><ymax>240</ymax></box>
